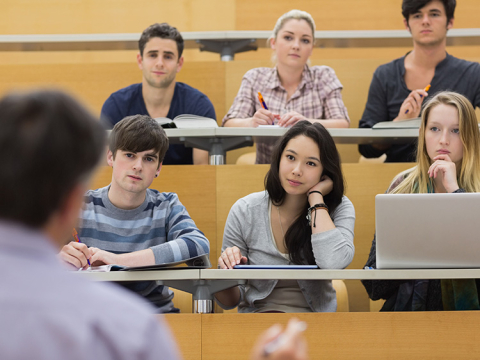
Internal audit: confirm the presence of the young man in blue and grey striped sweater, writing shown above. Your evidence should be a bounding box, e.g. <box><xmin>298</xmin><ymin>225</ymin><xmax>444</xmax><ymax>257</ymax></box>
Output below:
<box><xmin>60</xmin><ymin>115</ymin><xmax>210</xmax><ymax>312</ymax></box>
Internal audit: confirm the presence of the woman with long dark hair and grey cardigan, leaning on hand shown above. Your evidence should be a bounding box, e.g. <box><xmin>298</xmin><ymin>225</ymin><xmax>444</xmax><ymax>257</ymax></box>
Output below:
<box><xmin>216</xmin><ymin>121</ymin><xmax>355</xmax><ymax>312</ymax></box>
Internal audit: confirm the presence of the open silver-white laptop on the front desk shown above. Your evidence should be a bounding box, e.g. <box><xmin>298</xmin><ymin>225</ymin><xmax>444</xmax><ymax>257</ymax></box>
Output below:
<box><xmin>375</xmin><ymin>193</ymin><xmax>480</xmax><ymax>269</ymax></box>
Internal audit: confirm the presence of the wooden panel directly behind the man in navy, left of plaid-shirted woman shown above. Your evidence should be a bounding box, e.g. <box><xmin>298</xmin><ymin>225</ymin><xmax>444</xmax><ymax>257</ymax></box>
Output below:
<box><xmin>0</xmin><ymin>60</ymin><xmax>225</xmax><ymax>116</ymax></box>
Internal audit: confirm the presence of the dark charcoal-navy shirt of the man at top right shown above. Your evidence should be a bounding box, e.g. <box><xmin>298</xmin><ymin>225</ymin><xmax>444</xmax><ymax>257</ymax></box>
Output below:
<box><xmin>358</xmin><ymin>54</ymin><xmax>480</xmax><ymax>162</ymax></box>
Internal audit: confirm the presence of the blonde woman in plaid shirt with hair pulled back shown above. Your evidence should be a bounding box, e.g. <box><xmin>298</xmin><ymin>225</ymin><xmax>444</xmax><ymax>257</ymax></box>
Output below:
<box><xmin>222</xmin><ymin>10</ymin><xmax>350</xmax><ymax>164</ymax></box>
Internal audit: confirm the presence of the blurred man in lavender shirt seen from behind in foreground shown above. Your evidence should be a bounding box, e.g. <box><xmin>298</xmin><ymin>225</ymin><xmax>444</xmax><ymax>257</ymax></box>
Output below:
<box><xmin>0</xmin><ymin>91</ymin><xmax>179</xmax><ymax>360</ymax></box>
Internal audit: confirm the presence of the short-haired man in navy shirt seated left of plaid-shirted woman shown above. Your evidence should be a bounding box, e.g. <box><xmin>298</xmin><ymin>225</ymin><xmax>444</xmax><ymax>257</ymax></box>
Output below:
<box><xmin>101</xmin><ymin>23</ymin><xmax>216</xmax><ymax>165</ymax></box>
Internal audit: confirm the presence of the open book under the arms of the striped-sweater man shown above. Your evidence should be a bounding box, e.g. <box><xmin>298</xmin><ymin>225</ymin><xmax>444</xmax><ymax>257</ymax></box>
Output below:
<box><xmin>79</xmin><ymin>254</ymin><xmax>212</xmax><ymax>272</ymax></box>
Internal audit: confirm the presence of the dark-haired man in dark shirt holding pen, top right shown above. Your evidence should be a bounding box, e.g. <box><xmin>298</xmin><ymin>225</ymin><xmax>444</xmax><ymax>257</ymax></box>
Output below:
<box><xmin>359</xmin><ymin>0</ymin><xmax>480</xmax><ymax>162</ymax></box>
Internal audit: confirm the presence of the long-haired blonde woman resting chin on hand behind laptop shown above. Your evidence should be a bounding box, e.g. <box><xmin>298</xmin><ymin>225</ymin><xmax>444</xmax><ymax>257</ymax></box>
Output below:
<box><xmin>362</xmin><ymin>92</ymin><xmax>480</xmax><ymax>311</ymax></box>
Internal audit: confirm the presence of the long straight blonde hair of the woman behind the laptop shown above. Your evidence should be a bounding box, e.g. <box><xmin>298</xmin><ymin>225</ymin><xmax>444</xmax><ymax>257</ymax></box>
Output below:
<box><xmin>391</xmin><ymin>91</ymin><xmax>480</xmax><ymax>194</ymax></box>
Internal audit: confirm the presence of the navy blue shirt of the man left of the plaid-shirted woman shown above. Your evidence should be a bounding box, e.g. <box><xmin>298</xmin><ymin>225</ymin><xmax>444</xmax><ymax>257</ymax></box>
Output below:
<box><xmin>101</xmin><ymin>82</ymin><xmax>216</xmax><ymax>165</ymax></box>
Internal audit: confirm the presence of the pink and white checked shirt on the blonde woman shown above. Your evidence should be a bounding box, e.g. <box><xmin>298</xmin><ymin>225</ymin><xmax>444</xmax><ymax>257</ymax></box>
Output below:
<box><xmin>222</xmin><ymin>65</ymin><xmax>350</xmax><ymax>164</ymax></box>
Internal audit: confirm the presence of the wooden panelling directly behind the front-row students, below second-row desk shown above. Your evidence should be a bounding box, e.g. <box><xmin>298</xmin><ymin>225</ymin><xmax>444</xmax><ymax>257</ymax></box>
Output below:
<box><xmin>91</xmin><ymin>164</ymin><xmax>411</xmax><ymax>311</ymax></box>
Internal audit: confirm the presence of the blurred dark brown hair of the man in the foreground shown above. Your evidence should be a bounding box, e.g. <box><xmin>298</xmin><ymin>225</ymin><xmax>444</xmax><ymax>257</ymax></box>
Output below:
<box><xmin>0</xmin><ymin>90</ymin><xmax>105</xmax><ymax>228</ymax></box>
